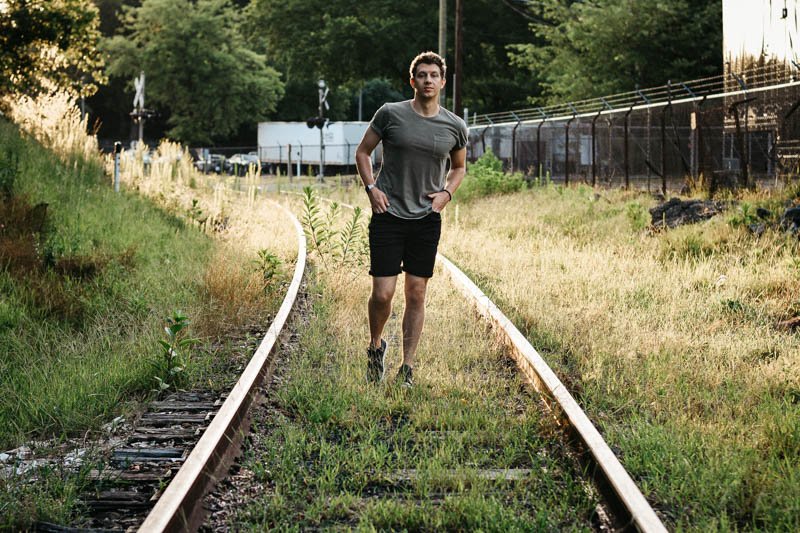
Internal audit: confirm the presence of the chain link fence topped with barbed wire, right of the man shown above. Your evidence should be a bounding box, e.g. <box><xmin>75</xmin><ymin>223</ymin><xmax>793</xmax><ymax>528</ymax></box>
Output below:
<box><xmin>468</xmin><ymin>72</ymin><xmax>800</xmax><ymax>193</ymax></box>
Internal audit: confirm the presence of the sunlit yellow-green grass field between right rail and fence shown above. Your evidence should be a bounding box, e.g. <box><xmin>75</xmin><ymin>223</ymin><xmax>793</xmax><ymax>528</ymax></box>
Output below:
<box><xmin>432</xmin><ymin>186</ymin><xmax>800</xmax><ymax>530</ymax></box>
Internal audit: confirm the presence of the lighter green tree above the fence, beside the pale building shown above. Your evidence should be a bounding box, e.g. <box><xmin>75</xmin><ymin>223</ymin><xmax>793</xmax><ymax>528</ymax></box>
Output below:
<box><xmin>511</xmin><ymin>0</ymin><xmax>722</xmax><ymax>103</ymax></box>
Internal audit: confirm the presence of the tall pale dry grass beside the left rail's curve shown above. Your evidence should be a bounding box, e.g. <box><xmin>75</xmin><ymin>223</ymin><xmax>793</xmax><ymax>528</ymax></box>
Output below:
<box><xmin>112</xmin><ymin>140</ymin><xmax>297</xmax><ymax>337</ymax></box>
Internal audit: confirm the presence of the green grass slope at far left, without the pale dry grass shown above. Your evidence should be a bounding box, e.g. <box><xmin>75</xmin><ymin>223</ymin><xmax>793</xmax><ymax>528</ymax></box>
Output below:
<box><xmin>0</xmin><ymin>117</ymin><xmax>212</xmax><ymax>449</ymax></box>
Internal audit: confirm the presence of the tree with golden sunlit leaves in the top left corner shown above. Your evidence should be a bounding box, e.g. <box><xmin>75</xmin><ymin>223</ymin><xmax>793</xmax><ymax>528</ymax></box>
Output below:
<box><xmin>0</xmin><ymin>0</ymin><xmax>105</xmax><ymax>96</ymax></box>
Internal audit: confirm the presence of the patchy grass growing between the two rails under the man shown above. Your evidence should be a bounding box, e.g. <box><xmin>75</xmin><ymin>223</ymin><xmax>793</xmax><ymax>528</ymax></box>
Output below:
<box><xmin>225</xmin><ymin>195</ymin><xmax>596</xmax><ymax>531</ymax></box>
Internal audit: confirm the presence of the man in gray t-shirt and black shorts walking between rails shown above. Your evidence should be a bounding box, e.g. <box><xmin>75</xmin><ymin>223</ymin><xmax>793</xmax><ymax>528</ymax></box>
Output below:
<box><xmin>356</xmin><ymin>52</ymin><xmax>467</xmax><ymax>387</ymax></box>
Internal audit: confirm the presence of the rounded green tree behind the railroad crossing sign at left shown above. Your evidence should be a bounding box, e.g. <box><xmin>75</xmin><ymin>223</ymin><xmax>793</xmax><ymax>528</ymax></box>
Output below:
<box><xmin>104</xmin><ymin>0</ymin><xmax>283</xmax><ymax>144</ymax></box>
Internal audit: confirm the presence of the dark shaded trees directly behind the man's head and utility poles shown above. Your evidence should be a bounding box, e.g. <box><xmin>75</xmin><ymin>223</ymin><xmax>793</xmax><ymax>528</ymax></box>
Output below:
<box><xmin>247</xmin><ymin>0</ymin><xmax>538</xmax><ymax>119</ymax></box>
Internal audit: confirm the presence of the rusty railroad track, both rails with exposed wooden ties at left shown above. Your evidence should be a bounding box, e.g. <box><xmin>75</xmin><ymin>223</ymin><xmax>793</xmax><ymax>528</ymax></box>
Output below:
<box><xmin>34</xmin><ymin>190</ymin><xmax>666</xmax><ymax>532</ymax></box>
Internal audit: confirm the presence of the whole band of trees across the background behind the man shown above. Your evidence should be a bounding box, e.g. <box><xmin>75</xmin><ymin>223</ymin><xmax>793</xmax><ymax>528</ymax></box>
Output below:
<box><xmin>9</xmin><ymin>0</ymin><xmax>722</xmax><ymax>144</ymax></box>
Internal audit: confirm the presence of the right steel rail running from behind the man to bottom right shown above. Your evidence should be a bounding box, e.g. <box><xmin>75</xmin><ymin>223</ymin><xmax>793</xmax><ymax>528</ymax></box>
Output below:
<box><xmin>285</xmin><ymin>191</ymin><xmax>667</xmax><ymax>533</ymax></box>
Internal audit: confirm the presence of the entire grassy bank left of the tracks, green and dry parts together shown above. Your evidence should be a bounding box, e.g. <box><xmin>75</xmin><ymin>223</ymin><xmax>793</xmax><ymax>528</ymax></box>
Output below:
<box><xmin>0</xmin><ymin>89</ymin><xmax>296</xmax><ymax>529</ymax></box>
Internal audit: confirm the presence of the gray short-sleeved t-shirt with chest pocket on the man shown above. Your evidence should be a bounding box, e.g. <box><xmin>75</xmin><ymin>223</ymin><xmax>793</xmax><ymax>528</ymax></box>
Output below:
<box><xmin>369</xmin><ymin>100</ymin><xmax>467</xmax><ymax>219</ymax></box>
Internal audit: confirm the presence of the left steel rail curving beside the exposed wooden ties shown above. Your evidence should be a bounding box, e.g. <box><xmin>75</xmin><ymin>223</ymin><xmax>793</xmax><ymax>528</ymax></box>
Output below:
<box><xmin>139</xmin><ymin>197</ymin><xmax>306</xmax><ymax>533</ymax></box>
